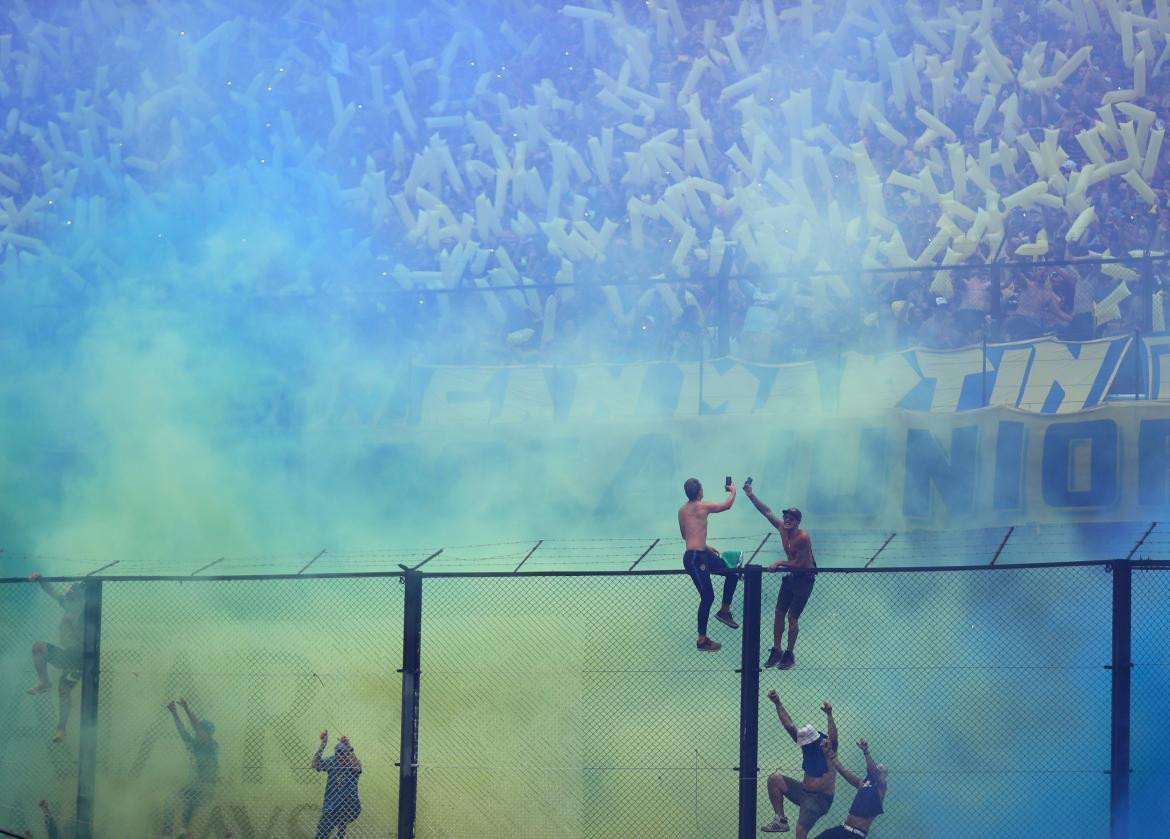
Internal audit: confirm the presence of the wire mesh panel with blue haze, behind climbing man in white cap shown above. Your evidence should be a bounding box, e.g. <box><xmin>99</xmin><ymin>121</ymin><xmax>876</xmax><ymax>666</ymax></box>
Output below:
<box><xmin>758</xmin><ymin>568</ymin><xmax>1110</xmax><ymax>839</ymax></box>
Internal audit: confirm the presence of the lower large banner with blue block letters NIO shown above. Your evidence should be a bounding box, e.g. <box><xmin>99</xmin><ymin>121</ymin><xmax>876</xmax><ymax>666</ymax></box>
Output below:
<box><xmin>367</xmin><ymin>403</ymin><xmax>1170</xmax><ymax>532</ymax></box>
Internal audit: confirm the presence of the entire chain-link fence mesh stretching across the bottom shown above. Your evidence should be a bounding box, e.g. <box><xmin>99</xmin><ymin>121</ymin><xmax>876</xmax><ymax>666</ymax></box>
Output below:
<box><xmin>0</xmin><ymin>559</ymin><xmax>1170</xmax><ymax>839</ymax></box>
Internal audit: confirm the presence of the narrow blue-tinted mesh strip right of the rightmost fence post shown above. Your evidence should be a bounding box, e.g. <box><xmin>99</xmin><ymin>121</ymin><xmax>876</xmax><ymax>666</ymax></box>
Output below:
<box><xmin>1129</xmin><ymin>570</ymin><xmax>1170</xmax><ymax>835</ymax></box>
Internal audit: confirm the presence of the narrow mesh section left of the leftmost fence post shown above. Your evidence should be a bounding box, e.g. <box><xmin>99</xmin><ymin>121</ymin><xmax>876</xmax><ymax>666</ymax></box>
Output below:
<box><xmin>0</xmin><ymin>583</ymin><xmax>81</xmax><ymax>835</ymax></box>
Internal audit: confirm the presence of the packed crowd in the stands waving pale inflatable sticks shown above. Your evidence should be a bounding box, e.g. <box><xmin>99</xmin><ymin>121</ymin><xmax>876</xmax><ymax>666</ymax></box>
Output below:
<box><xmin>0</xmin><ymin>0</ymin><xmax>1170</xmax><ymax>363</ymax></box>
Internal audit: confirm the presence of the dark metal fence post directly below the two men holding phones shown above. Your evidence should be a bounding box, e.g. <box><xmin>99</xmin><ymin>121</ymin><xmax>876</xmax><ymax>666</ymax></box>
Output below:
<box><xmin>738</xmin><ymin>565</ymin><xmax>764</xmax><ymax>839</ymax></box>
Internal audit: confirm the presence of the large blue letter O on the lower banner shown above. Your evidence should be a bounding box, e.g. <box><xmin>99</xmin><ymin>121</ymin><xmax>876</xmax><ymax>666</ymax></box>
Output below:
<box><xmin>1040</xmin><ymin>420</ymin><xmax>1119</xmax><ymax>507</ymax></box>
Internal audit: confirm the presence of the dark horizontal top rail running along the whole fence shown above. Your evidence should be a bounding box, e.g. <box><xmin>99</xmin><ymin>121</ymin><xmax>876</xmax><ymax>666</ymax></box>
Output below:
<box><xmin>0</xmin><ymin>558</ymin><xmax>1170</xmax><ymax>585</ymax></box>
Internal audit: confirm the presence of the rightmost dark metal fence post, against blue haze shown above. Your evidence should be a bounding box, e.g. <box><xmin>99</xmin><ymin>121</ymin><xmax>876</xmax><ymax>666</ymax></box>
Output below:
<box><xmin>1109</xmin><ymin>559</ymin><xmax>1133</xmax><ymax>839</ymax></box>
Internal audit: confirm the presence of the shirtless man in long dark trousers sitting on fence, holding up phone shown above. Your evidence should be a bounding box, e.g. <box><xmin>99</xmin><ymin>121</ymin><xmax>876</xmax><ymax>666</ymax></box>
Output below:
<box><xmin>679</xmin><ymin>477</ymin><xmax>739</xmax><ymax>653</ymax></box>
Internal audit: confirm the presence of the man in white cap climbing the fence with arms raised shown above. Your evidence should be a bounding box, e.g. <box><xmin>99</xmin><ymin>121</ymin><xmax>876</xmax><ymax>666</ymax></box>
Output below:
<box><xmin>759</xmin><ymin>690</ymin><xmax>837</xmax><ymax>839</ymax></box>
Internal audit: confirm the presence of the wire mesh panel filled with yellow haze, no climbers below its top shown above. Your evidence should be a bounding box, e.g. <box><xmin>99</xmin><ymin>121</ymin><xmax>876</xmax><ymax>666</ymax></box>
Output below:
<box><xmin>418</xmin><ymin>573</ymin><xmax>739</xmax><ymax>839</ymax></box>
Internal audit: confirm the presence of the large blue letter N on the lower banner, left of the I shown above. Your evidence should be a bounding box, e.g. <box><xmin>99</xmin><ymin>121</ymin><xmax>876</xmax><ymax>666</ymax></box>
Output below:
<box><xmin>902</xmin><ymin>426</ymin><xmax>979</xmax><ymax>518</ymax></box>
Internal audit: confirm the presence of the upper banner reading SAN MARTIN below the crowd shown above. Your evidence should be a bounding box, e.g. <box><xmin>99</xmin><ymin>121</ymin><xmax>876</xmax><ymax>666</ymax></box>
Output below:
<box><xmin>410</xmin><ymin>336</ymin><xmax>1151</xmax><ymax>426</ymax></box>
